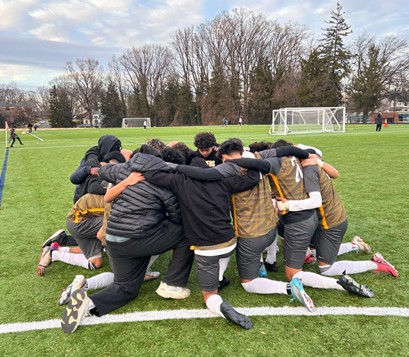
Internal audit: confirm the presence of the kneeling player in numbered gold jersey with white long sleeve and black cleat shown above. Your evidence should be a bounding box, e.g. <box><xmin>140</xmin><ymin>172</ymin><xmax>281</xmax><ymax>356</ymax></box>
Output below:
<box><xmin>228</xmin><ymin>140</ymin><xmax>374</xmax><ymax>297</ymax></box>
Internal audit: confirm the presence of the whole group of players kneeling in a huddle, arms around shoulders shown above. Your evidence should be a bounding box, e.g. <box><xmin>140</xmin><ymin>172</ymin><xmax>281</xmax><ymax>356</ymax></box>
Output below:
<box><xmin>38</xmin><ymin>132</ymin><xmax>398</xmax><ymax>333</ymax></box>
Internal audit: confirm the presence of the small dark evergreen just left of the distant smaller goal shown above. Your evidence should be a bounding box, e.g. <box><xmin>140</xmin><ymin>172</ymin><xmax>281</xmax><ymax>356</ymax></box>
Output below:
<box><xmin>101</xmin><ymin>82</ymin><xmax>126</xmax><ymax>127</ymax></box>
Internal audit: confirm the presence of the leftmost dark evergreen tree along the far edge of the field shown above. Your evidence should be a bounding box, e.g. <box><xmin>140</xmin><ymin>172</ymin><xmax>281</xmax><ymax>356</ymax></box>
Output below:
<box><xmin>49</xmin><ymin>85</ymin><xmax>74</xmax><ymax>128</ymax></box>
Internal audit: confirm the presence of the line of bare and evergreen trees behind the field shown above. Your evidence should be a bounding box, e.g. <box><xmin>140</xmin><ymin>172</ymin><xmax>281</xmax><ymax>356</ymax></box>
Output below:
<box><xmin>0</xmin><ymin>3</ymin><xmax>409</xmax><ymax>127</ymax></box>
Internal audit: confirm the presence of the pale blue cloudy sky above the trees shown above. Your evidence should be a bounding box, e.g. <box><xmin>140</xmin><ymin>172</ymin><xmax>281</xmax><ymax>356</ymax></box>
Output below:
<box><xmin>0</xmin><ymin>0</ymin><xmax>409</xmax><ymax>90</ymax></box>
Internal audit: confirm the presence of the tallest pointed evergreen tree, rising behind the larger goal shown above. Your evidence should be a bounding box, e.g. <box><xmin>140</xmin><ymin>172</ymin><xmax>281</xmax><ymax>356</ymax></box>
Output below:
<box><xmin>319</xmin><ymin>3</ymin><xmax>352</xmax><ymax>106</ymax></box>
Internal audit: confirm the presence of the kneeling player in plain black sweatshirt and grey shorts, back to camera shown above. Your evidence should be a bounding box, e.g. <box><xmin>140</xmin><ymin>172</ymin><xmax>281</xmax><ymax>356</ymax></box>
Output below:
<box><xmin>131</xmin><ymin>149</ymin><xmax>260</xmax><ymax>329</ymax></box>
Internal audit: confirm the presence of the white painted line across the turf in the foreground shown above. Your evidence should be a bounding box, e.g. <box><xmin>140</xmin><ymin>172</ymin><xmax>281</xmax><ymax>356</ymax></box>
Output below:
<box><xmin>0</xmin><ymin>307</ymin><xmax>409</xmax><ymax>334</ymax></box>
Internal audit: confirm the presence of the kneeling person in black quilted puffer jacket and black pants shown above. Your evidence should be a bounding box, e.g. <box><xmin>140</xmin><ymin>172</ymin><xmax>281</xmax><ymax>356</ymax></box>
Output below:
<box><xmin>61</xmin><ymin>145</ymin><xmax>193</xmax><ymax>333</ymax></box>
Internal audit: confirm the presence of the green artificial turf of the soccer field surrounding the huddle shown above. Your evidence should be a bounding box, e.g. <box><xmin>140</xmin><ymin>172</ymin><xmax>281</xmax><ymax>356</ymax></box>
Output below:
<box><xmin>0</xmin><ymin>125</ymin><xmax>409</xmax><ymax>356</ymax></box>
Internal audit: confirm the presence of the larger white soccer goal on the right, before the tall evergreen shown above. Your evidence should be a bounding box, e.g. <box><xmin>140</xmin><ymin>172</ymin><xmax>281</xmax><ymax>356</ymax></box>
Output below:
<box><xmin>270</xmin><ymin>107</ymin><xmax>345</xmax><ymax>135</ymax></box>
